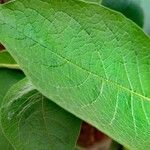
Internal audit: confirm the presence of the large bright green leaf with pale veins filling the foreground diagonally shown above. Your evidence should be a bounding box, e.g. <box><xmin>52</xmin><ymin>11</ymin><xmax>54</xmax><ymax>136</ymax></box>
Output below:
<box><xmin>0</xmin><ymin>0</ymin><xmax>150</xmax><ymax>150</ymax></box>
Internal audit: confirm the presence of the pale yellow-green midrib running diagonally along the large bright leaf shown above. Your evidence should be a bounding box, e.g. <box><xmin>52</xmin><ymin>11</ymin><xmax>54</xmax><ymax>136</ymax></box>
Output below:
<box><xmin>3</xmin><ymin>9</ymin><xmax>150</xmax><ymax>101</ymax></box>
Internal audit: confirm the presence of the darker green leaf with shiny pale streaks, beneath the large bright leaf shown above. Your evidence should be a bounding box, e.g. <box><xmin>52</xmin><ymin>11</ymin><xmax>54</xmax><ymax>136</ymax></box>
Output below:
<box><xmin>1</xmin><ymin>79</ymin><xmax>81</xmax><ymax>150</ymax></box>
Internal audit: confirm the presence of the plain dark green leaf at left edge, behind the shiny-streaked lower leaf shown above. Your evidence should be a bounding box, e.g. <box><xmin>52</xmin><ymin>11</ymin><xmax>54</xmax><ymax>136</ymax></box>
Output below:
<box><xmin>0</xmin><ymin>69</ymin><xmax>24</xmax><ymax>150</ymax></box>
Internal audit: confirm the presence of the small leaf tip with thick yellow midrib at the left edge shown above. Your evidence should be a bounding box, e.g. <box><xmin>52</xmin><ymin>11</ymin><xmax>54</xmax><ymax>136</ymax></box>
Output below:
<box><xmin>0</xmin><ymin>50</ymin><xmax>19</xmax><ymax>69</ymax></box>
